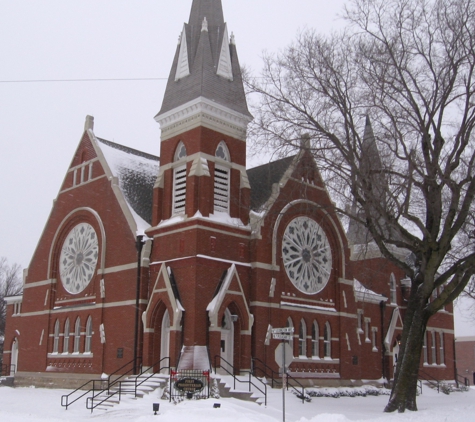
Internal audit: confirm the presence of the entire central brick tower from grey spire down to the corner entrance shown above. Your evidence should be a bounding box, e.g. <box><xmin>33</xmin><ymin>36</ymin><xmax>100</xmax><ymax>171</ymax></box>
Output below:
<box><xmin>145</xmin><ymin>0</ymin><xmax>252</xmax><ymax>369</ymax></box>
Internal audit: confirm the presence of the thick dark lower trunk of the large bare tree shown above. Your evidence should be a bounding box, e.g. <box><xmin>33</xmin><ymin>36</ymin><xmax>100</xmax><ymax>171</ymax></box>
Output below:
<box><xmin>384</xmin><ymin>297</ymin><xmax>428</xmax><ymax>413</ymax></box>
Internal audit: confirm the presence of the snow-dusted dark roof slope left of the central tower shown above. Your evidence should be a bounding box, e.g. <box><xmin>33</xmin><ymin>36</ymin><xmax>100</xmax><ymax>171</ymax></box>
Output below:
<box><xmin>95</xmin><ymin>137</ymin><xmax>160</xmax><ymax>226</ymax></box>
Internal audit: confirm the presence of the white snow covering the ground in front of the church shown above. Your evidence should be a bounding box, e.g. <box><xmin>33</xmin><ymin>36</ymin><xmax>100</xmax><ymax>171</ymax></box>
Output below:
<box><xmin>0</xmin><ymin>387</ymin><xmax>475</xmax><ymax>422</ymax></box>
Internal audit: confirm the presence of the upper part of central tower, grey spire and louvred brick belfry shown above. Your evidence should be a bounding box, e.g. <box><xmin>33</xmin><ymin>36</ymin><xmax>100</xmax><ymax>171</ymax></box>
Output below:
<box><xmin>153</xmin><ymin>0</ymin><xmax>252</xmax><ymax>225</ymax></box>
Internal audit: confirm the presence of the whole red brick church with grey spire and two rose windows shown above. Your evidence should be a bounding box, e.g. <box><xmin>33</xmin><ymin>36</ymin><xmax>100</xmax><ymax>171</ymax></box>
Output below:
<box><xmin>3</xmin><ymin>0</ymin><xmax>454</xmax><ymax>386</ymax></box>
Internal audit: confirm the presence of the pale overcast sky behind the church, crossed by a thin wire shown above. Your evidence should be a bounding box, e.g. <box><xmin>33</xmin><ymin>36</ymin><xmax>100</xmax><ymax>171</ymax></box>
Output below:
<box><xmin>0</xmin><ymin>0</ymin><xmax>475</xmax><ymax>335</ymax></box>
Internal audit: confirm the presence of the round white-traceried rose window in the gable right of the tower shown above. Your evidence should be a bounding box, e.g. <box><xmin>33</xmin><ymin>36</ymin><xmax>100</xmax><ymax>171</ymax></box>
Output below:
<box><xmin>282</xmin><ymin>217</ymin><xmax>332</xmax><ymax>294</ymax></box>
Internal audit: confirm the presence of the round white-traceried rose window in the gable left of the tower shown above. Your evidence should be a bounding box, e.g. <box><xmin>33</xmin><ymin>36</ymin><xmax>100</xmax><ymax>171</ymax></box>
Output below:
<box><xmin>59</xmin><ymin>223</ymin><xmax>99</xmax><ymax>294</ymax></box>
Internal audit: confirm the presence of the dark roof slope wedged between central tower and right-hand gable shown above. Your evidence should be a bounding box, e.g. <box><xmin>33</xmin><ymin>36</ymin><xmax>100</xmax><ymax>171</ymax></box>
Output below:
<box><xmin>247</xmin><ymin>155</ymin><xmax>296</xmax><ymax>211</ymax></box>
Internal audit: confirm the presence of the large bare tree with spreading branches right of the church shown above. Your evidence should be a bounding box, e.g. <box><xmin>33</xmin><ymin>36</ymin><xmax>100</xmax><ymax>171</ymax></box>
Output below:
<box><xmin>247</xmin><ymin>0</ymin><xmax>475</xmax><ymax>412</ymax></box>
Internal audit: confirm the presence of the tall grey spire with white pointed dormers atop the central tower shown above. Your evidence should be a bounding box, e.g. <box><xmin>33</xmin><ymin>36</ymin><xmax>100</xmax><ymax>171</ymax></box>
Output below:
<box><xmin>156</xmin><ymin>0</ymin><xmax>252</xmax><ymax>121</ymax></box>
